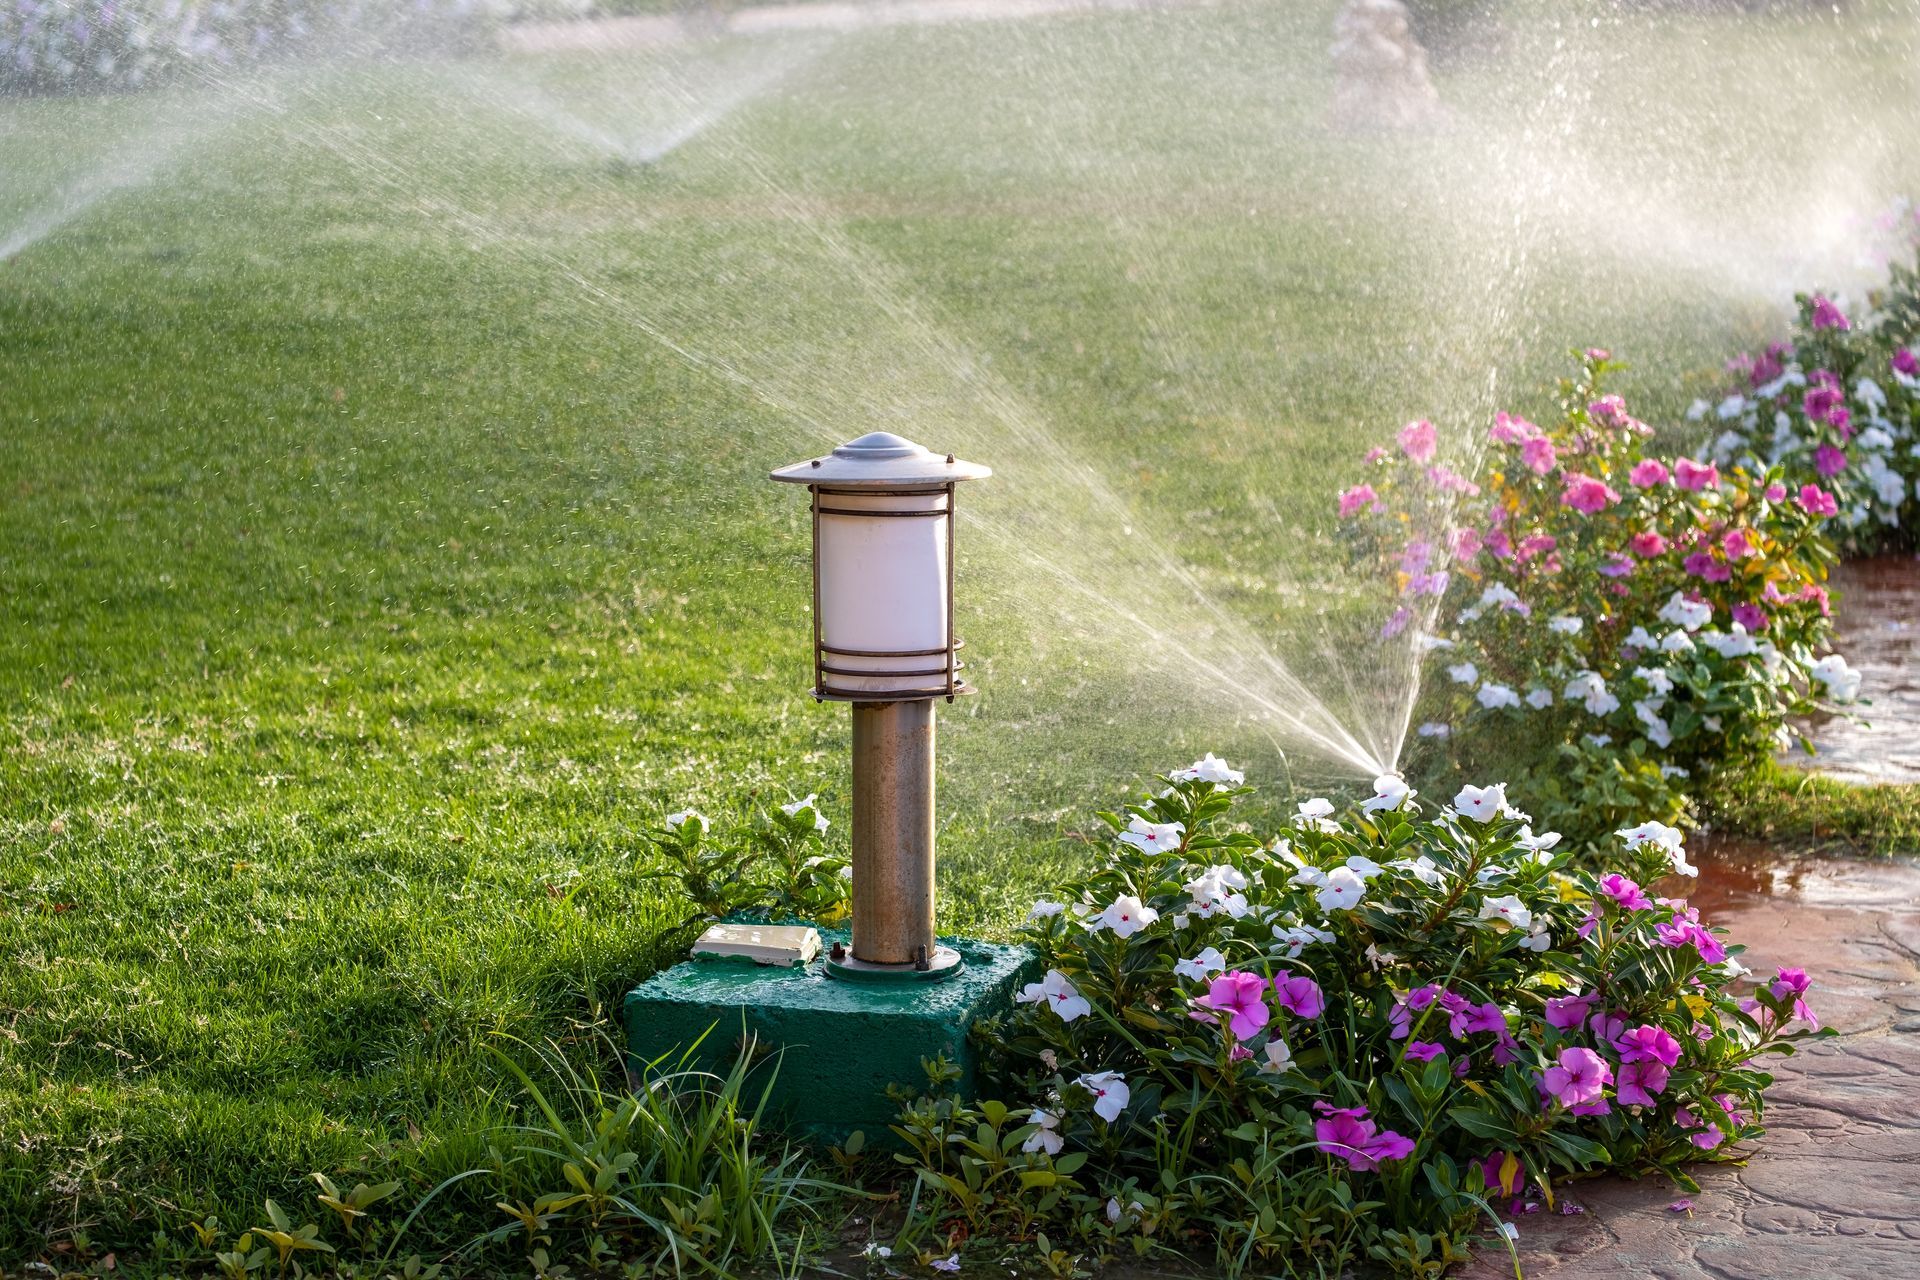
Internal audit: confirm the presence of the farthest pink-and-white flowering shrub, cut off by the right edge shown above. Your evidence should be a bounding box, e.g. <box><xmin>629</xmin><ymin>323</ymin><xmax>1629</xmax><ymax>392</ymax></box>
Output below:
<box><xmin>1690</xmin><ymin>222</ymin><xmax>1920</xmax><ymax>551</ymax></box>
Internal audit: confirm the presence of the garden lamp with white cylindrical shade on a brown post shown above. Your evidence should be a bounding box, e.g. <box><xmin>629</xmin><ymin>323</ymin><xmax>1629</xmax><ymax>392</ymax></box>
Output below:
<box><xmin>772</xmin><ymin>432</ymin><xmax>993</xmax><ymax>981</ymax></box>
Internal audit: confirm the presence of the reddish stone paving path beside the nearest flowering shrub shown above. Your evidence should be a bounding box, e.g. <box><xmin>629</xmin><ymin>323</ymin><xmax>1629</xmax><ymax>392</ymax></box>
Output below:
<box><xmin>1461</xmin><ymin>844</ymin><xmax>1920</xmax><ymax>1280</ymax></box>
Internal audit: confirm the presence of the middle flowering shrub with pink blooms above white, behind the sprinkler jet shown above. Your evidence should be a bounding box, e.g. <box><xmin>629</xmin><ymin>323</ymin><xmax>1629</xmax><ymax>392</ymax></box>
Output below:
<box><xmin>1340</xmin><ymin>351</ymin><xmax>1859</xmax><ymax>844</ymax></box>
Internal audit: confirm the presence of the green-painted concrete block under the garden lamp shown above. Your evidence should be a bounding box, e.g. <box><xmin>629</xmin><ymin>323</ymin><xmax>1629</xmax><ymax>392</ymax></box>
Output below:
<box><xmin>622</xmin><ymin>933</ymin><xmax>1039</xmax><ymax>1144</ymax></box>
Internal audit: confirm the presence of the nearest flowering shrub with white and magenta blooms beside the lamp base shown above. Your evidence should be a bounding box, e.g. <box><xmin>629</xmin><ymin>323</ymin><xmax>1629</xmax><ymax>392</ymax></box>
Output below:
<box><xmin>897</xmin><ymin>758</ymin><xmax>1818</xmax><ymax>1276</ymax></box>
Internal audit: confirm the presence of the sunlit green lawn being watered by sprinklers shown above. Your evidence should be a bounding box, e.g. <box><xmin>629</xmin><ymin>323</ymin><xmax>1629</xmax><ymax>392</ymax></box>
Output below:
<box><xmin>0</xmin><ymin>2</ymin><xmax>1920</xmax><ymax>1261</ymax></box>
